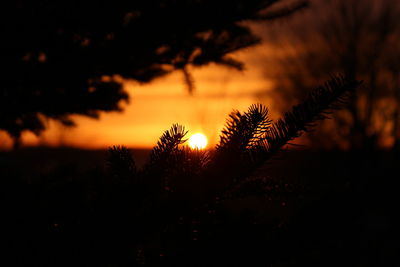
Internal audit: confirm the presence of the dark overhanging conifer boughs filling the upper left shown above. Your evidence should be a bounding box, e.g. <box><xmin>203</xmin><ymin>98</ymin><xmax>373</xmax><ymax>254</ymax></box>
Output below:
<box><xmin>0</xmin><ymin>0</ymin><xmax>304</xmax><ymax>149</ymax></box>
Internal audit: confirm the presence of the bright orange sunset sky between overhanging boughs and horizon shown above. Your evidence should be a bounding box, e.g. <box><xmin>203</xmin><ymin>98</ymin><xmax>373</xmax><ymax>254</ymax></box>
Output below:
<box><xmin>0</xmin><ymin>42</ymin><xmax>271</xmax><ymax>151</ymax></box>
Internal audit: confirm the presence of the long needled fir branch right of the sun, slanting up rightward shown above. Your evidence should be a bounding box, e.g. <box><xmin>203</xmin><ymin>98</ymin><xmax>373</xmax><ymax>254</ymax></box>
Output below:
<box><xmin>205</xmin><ymin>77</ymin><xmax>360</xmax><ymax>200</ymax></box>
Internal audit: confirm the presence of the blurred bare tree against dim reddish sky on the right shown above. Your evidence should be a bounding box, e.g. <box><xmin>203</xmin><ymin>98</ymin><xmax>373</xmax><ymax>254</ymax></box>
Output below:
<box><xmin>265</xmin><ymin>0</ymin><xmax>400</xmax><ymax>149</ymax></box>
